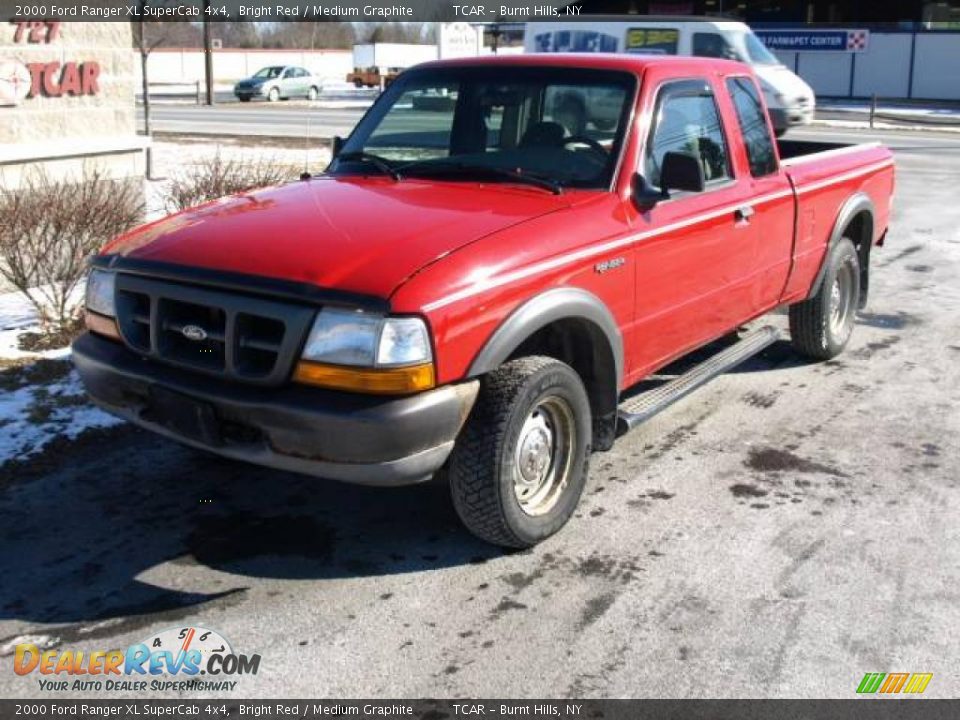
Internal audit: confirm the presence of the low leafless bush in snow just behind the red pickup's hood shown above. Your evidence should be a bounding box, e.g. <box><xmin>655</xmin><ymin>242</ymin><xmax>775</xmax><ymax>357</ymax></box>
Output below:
<box><xmin>165</xmin><ymin>152</ymin><xmax>299</xmax><ymax>212</ymax></box>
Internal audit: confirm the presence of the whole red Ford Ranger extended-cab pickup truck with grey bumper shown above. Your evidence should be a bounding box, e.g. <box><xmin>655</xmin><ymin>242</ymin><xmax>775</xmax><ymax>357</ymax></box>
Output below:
<box><xmin>74</xmin><ymin>55</ymin><xmax>894</xmax><ymax>547</ymax></box>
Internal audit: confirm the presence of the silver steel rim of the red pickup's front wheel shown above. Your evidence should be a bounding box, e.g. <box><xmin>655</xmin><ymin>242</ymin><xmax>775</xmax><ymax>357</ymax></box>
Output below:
<box><xmin>513</xmin><ymin>396</ymin><xmax>577</xmax><ymax>516</ymax></box>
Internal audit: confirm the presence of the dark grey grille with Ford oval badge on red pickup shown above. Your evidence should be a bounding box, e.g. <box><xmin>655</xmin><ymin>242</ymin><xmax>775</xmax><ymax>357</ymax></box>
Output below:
<box><xmin>116</xmin><ymin>273</ymin><xmax>315</xmax><ymax>385</ymax></box>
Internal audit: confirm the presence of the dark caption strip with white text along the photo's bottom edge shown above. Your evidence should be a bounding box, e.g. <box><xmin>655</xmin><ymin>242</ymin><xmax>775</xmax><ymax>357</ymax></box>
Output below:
<box><xmin>0</xmin><ymin>698</ymin><xmax>960</xmax><ymax>720</ymax></box>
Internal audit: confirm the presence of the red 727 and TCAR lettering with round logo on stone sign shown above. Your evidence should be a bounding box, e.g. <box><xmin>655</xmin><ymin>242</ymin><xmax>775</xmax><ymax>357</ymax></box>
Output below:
<box><xmin>0</xmin><ymin>20</ymin><xmax>100</xmax><ymax>107</ymax></box>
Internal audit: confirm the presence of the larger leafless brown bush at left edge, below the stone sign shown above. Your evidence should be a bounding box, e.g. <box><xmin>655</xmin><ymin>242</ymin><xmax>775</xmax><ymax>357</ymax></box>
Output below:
<box><xmin>0</xmin><ymin>169</ymin><xmax>143</xmax><ymax>336</ymax></box>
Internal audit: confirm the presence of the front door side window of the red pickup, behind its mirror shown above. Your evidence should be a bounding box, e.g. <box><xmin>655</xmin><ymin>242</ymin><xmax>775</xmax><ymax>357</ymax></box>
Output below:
<box><xmin>643</xmin><ymin>80</ymin><xmax>733</xmax><ymax>188</ymax></box>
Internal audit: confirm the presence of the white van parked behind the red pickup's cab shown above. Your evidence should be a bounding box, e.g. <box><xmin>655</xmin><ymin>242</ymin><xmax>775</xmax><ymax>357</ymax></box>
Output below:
<box><xmin>524</xmin><ymin>15</ymin><xmax>816</xmax><ymax>135</ymax></box>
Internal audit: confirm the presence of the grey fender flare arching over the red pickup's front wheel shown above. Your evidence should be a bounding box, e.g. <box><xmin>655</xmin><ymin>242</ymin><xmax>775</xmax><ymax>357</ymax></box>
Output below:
<box><xmin>467</xmin><ymin>287</ymin><xmax>623</xmax><ymax>391</ymax></box>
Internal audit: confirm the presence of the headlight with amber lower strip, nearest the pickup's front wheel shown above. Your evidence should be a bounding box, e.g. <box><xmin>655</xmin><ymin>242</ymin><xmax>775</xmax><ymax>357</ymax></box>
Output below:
<box><xmin>294</xmin><ymin>308</ymin><xmax>435</xmax><ymax>394</ymax></box>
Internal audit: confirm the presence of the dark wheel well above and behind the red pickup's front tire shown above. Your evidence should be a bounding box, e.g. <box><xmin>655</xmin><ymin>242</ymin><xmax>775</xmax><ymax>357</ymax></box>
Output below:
<box><xmin>508</xmin><ymin>318</ymin><xmax>619</xmax><ymax>450</ymax></box>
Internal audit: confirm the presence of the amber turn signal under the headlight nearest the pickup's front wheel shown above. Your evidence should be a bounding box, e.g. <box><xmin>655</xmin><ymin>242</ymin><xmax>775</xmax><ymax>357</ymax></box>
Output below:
<box><xmin>293</xmin><ymin>360</ymin><xmax>436</xmax><ymax>395</ymax></box>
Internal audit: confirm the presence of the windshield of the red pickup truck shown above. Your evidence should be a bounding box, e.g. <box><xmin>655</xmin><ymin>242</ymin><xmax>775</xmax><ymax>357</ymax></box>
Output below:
<box><xmin>331</xmin><ymin>66</ymin><xmax>635</xmax><ymax>188</ymax></box>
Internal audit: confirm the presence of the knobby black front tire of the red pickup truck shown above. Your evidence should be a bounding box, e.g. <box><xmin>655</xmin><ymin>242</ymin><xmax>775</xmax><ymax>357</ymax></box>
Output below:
<box><xmin>449</xmin><ymin>356</ymin><xmax>592</xmax><ymax>548</ymax></box>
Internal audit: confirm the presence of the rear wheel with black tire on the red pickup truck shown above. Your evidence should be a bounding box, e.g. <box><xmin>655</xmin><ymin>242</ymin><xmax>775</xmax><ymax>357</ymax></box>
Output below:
<box><xmin>790</xmin><ymin>238</ymin><xmax>860</xmax><ymax>360</ymax></box>
